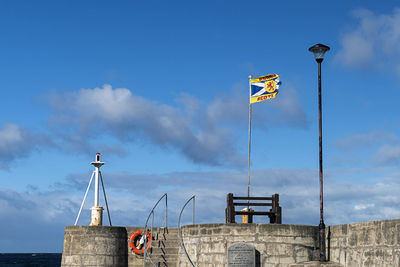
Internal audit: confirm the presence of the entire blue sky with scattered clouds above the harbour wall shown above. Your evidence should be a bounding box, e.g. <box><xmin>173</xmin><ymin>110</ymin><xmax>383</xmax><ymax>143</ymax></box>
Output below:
<box><xmin>0</xmin><ymin>1</ymin><xmax>400</xmax><ymax>252</ymax></box>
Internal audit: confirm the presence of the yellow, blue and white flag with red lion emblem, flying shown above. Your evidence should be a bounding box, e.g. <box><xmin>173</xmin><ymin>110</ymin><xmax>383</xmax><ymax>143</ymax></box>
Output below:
<box><xmin>250</xmin><ymin>74</ymin><xmax>281</xmax><ymax>104</ymax></box>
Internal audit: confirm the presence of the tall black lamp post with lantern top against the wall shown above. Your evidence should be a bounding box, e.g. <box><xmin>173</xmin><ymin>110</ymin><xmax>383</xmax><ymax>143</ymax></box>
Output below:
<box><xmin>308</xmin><ymin>44</ymin><xmax>330</xmax><ymax>261</ymax></box>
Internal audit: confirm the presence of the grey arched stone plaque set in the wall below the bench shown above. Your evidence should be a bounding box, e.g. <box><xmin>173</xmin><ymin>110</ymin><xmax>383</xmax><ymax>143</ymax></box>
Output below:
<box><xmin>228</xmin><ymin>243</ymin><xmax>256</xmax><ymax>267</ymax></box>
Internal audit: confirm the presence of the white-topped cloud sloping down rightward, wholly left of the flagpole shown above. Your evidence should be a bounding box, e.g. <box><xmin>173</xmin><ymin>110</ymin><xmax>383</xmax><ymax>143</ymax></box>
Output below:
<box><xmin>48</xmin><ymin>85</ymin><xmax>236</xmax><ymax>165</ymax></box>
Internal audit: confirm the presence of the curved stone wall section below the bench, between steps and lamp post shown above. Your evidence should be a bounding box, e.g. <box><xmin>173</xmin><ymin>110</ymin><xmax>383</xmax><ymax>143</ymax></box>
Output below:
<box><xmin>178</xmin><ymin>224</ymin><xmax>319</xmax><ymax>267</ymax></box>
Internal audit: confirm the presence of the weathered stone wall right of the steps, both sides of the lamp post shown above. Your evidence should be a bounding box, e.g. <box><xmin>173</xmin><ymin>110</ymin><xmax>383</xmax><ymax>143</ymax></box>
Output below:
<box><xmin>179</xmin><ymin>219</ymin><xmax>400</xmax><ymax>267</ymax></box>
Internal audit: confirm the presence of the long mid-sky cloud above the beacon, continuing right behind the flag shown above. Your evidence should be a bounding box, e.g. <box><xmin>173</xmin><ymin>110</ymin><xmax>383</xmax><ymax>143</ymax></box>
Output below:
<box><xmin>46</xmin><ymin>85</ymin><xmax>307</xmax><ymax>167</ymax></box>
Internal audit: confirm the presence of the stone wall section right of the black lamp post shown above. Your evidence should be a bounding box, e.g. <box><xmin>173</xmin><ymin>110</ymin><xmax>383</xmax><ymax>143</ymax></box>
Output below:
<box><xmin>327</xmin><ymin>219</ymin><xmax>400</xmax><ymax>267</ymax></box>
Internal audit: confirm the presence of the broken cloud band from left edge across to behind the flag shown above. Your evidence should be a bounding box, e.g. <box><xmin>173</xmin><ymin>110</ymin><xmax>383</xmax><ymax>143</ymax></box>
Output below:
<box><xmin>0</xmin><ymin>85</ymin><xmax>307</xmax><ymax>169</ymax></box>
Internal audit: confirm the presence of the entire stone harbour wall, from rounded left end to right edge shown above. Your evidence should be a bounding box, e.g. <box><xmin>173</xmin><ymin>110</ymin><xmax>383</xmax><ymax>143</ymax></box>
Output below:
<box><xmin>62</xmin><ymin>219</ymin><xmax>400</xmax><ymax>267</ymax></box>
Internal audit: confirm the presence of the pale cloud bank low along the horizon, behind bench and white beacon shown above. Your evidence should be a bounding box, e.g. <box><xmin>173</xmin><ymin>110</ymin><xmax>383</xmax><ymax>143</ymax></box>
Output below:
<box><xmin>0</xmin><ymin>169</ymin><xmax>400</xmax><ymax>252</ymax></box>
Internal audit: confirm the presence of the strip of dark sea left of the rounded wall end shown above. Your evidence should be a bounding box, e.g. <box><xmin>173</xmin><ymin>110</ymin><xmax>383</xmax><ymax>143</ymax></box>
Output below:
<box><xmin>0</xmin><ymin>253</ymin><xmax>61</xmax><ymax>267</ymax></box>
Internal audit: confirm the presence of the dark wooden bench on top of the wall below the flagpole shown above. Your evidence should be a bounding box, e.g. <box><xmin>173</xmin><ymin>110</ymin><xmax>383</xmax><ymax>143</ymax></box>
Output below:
<box><xmin>225</xmin><ymin>193</ymin><xmax>282</xmax><ymax>224</ymax></box>
